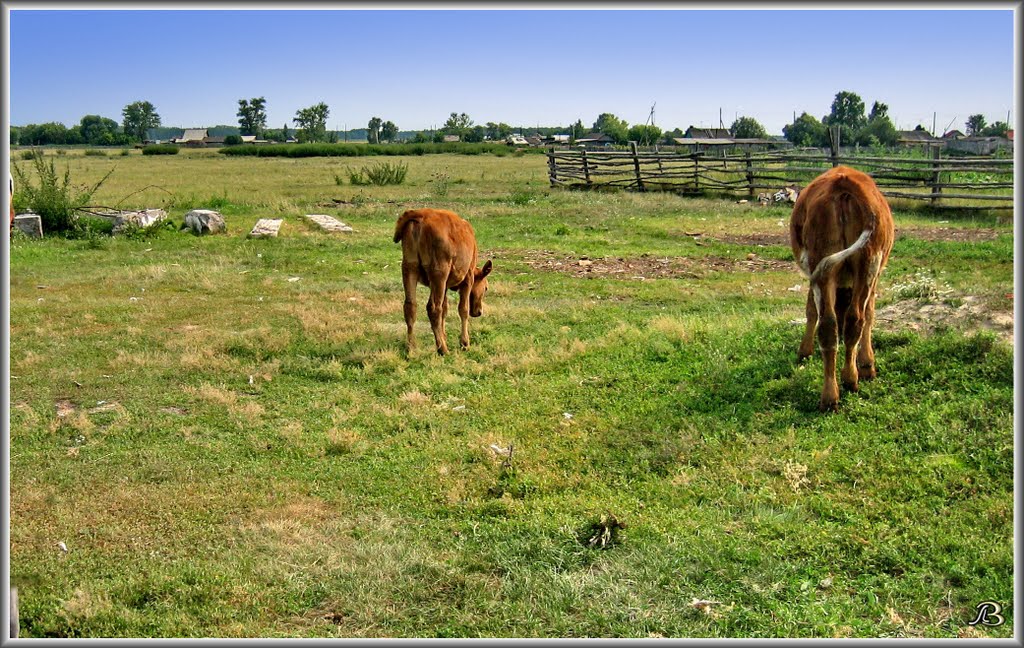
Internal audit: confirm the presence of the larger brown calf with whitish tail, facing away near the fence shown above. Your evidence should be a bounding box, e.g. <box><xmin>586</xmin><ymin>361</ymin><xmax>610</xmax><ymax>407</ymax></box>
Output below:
<box><xmin>790</xmin><ymin>166</ymin><xmax>894</xmax><ymax>412</ymax></box>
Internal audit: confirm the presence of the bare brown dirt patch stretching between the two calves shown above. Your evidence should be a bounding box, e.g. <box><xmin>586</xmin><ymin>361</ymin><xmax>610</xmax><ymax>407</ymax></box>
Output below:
<box><xmin>494</xmin><ymin>250</ymin><xmax>794</xmax><ymax>280</ymax></box>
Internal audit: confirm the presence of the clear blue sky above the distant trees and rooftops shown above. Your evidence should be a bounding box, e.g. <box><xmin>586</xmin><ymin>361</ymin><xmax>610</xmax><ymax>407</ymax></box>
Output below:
<box><xmin>8</xmin><ymin>4</ymin><xmax>1017</xmax><ymax>134</ymax></box>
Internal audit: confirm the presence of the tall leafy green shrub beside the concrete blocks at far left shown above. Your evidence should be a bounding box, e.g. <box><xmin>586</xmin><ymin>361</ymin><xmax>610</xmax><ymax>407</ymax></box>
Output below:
<box><xmin>12</xmin><ymin>156</ymin><xmax>114</xmax><ymax>232</ymax></box>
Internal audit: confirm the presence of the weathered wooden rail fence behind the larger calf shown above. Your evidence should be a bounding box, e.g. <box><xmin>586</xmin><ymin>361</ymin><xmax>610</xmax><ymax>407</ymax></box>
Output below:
<box><xmin>547</xmin><ymin>143</ymin><xmax>1014</xmax><ymax>209</ymax></box>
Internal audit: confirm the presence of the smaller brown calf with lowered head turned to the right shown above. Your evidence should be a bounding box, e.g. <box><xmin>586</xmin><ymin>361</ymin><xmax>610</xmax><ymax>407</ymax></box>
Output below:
<box><xmin>394</xmin><ymin>209</ymin><xmax>490</xmax><ymax>355</ymax></box>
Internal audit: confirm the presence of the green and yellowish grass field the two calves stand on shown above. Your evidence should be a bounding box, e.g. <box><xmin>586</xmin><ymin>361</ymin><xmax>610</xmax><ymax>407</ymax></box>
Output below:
<box><xmin>9</xmin><ymin>150</ymin><xmax>1015</xmax><ymax>638</ymax></box>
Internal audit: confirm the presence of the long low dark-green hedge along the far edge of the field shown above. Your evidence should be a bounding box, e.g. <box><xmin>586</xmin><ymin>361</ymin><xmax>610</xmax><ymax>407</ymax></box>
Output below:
<box><xmin>220</xmin><ymin>142</ymin><xmax>544</xmax><ymax>158</ymax></box>
